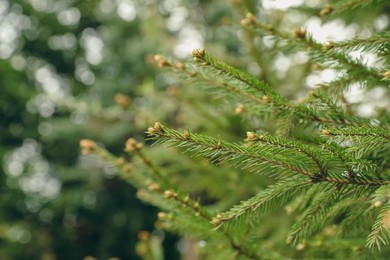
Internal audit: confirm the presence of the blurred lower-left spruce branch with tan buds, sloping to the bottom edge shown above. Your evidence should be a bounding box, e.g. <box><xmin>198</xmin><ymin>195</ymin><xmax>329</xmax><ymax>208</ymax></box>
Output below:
<box><xmin>80</xmin><ymin>137</ymin><xmax>260</xmax><ymax>259</ymax></box>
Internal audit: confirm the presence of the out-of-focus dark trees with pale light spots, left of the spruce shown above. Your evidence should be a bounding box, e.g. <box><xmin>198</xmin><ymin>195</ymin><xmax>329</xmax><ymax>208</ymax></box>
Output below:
<box><xmin>0</xmin><ymin>0</ymin><xmax>245</xmax><ymax>259</ymax></box>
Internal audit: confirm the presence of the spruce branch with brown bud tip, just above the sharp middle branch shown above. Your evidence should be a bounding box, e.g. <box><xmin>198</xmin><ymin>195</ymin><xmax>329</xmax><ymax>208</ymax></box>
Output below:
<box><xmin>155</xmin><ymin>49</ymin><xmax>366</xmax><ymax>125</ymax></box>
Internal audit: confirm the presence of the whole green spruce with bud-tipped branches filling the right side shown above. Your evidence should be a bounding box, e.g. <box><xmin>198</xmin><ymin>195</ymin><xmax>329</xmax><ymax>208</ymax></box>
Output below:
<box><xmin>80</xmin><ymin>0</ymin><xmax>390</xmax><ymax>259</ymax></box>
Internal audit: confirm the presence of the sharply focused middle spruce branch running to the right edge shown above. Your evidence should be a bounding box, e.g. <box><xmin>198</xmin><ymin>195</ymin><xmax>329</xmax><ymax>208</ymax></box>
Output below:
<box><xmin>147</xmin><ymin>123</ymin><xmax>390</xmax><ymax>186</ymax></box>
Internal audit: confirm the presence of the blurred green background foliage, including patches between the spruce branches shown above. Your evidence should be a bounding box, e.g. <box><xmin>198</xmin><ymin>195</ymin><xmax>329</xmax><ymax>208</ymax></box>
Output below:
<box><xmin>0</xmin><ymin>0</ymin><xmax>389</xmax><ymax>259</ymax></box>
